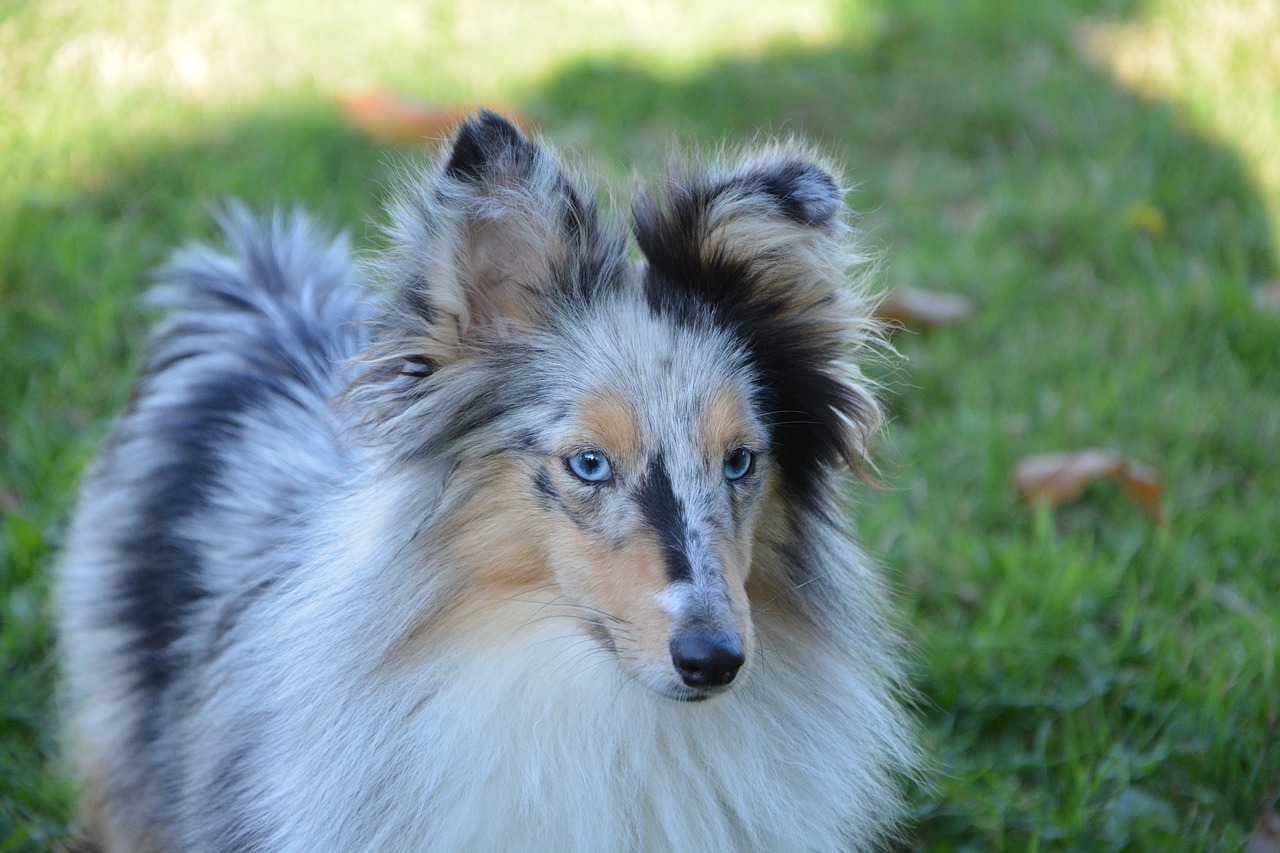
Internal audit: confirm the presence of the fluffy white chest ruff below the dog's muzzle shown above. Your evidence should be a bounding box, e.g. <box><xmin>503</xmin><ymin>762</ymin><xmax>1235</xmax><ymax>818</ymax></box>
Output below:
<box><xmin>244</xmin><ymin>596</ymin><xmax>910</xmax><ymax>853</ymax></box>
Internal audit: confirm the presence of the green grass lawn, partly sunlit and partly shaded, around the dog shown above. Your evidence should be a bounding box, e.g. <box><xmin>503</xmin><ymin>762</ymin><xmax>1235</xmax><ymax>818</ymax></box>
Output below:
<box><xmin>0</xmin><ymin>0</ymin><xmax>1280</xmax><ymax>850</ymax></box>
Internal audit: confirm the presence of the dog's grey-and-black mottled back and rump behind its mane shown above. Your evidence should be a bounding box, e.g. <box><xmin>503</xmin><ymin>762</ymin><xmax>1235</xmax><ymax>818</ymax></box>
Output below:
<box><xmin>59</xmin><ymin>206</ymin><xmax>367</xmax><ymax>849</ymax></box>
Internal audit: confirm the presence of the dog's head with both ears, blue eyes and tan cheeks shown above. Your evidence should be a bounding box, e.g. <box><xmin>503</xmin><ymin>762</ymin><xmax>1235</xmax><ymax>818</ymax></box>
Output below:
<box><xmin>362</xmin><ymin>113</ymin><xmax>879</xmax><ymax>699</ymax></box>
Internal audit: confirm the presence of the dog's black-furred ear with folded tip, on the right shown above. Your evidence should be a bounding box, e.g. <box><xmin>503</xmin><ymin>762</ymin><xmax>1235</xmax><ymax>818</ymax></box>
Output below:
<box><xmin>634</xmin><ymin>147</ymin><xmax>882</xmax><ymax>496</ymax></box>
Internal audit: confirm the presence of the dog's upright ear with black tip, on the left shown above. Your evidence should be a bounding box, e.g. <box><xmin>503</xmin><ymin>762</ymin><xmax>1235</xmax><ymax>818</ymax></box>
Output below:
<box><xmin>380</xmin><ymin>111</ymin><xmax>622</xmax><ymax>370</ymax></box>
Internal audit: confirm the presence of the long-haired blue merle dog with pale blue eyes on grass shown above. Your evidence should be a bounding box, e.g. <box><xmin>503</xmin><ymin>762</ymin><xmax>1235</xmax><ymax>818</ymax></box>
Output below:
<box><xmin>58</xmin><ymin>113</ymin><xmax>915</xmax><ymax>853</ymax></box>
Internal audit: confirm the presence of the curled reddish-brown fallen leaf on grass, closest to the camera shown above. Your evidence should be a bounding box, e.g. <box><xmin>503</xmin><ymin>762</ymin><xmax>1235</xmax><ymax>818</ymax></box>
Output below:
<box><xmin>1014</xmin><ymin>447</ymin><xmax>1164</xmax><ymax>521</ymax></box>
